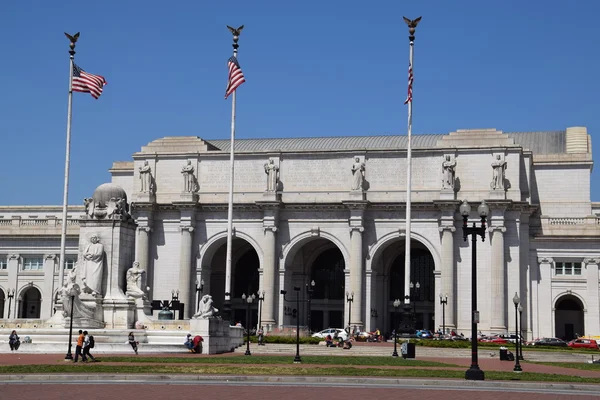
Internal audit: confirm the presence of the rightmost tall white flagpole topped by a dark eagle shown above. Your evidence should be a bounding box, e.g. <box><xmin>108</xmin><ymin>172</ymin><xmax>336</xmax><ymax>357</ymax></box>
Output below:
<box><xmin>404</xmin><ymin>17</ymin><xmax>421</xmax><ymax>304</ymax></box>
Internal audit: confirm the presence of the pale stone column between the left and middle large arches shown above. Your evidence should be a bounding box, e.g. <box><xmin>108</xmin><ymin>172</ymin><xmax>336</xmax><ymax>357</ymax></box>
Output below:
<box><xmin>261</xmin><ymin>226</ymin><xmax>277</xmax><ymax>331</ymax></box>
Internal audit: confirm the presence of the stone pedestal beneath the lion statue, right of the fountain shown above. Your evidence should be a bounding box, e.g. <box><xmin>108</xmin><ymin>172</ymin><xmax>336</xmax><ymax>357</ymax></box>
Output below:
<box><xmin>190</xmin><ymin>318</ymin><xmax>244</xmax><ymax>354</ymax></box>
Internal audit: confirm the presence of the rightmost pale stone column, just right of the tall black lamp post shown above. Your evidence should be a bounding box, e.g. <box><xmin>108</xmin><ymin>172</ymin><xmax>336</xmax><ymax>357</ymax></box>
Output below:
<box><xmin>488</xmin><ymin>225</ymin><xmax>508</xmax><ymax>333</ymax></box>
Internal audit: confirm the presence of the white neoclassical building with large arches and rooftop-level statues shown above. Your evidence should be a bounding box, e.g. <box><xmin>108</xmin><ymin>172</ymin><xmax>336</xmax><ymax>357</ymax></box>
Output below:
<box><xmin>0</xmin><ymin>127</ymin><xmax>600</xmax><ymax>338</ymax></box>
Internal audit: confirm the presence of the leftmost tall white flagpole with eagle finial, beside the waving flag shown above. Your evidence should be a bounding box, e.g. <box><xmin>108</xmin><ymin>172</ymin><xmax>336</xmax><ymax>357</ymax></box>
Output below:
<box><xmin>58</xmin><ymin>32</ymin><xmax>79</xmax><ymax>296</ymax></box>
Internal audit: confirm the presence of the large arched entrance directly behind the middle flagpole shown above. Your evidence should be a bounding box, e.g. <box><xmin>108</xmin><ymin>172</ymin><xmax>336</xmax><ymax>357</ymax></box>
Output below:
<box><xmin>202</xmin><ymin>238</ymin><xmax>260</xmax><ymax>327</ymax></box>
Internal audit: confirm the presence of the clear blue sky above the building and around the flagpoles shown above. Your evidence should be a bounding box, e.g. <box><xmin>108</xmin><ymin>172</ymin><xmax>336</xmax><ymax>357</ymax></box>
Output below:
<box><xmin>0</xmin><ymin>0</ymin><xmax>600</xmax><ymax>205</ymax></box>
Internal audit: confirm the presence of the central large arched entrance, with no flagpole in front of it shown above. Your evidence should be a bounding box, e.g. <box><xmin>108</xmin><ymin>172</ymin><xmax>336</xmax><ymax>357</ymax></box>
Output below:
<box><xmin>280</xmin><ymin>237</ymin><xmax>347</xmax><ymax>332</ymax></box>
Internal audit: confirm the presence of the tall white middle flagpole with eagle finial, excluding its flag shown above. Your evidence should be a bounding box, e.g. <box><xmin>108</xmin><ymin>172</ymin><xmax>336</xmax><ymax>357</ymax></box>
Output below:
<box><xmin>223</xmin><ymin>29</ymin><xmax>240</xmax><ymax>319</ymax></box>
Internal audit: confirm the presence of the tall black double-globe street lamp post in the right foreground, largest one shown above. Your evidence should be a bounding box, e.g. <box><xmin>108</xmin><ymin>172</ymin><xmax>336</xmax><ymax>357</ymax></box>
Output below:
<box><xmin>459</xmin><ymin>200</ymin><xmax>490</xmax><ymax>381</ymax></box>
